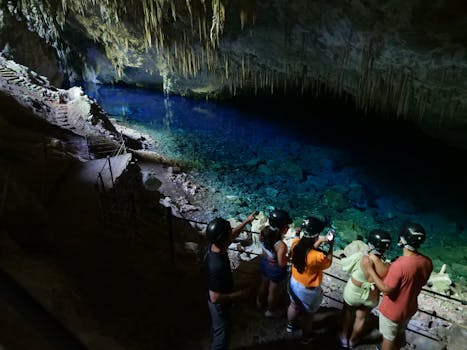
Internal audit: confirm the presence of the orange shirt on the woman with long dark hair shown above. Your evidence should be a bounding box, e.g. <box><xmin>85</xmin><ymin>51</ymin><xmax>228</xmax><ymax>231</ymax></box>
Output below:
<box><xmin>290</xmin><ymin>238</ymin><xmax>331</xmax><ymax>287</ymax></box>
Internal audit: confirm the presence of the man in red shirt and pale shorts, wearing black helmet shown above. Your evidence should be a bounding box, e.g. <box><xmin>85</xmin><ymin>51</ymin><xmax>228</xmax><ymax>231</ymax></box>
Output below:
<box><xmin>363</xmin><ymin>223</ymin><xmax>433</xmax><ymax>350</ymax></box>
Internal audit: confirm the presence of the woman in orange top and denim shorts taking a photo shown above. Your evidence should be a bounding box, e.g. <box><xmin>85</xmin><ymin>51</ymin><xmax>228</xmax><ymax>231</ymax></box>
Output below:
<box><xmin>287</xmin><ymin>216</ymin><xmax>334</xmax><ymax>344</ymax></box>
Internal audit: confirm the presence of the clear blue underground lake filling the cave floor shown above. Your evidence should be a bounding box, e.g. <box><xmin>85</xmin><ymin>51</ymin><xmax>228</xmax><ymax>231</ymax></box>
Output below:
<box><xmin>85</xmin><ymin>85</ymin><xmax>467</xmax><ymax>281</ymax></box>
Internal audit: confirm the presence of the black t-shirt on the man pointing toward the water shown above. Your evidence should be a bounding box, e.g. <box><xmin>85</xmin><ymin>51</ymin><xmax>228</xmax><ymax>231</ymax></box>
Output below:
<box><xmin>204</xmin><ymin>246</ymin><xmax>233</xmax><ymax>298</ymax></box>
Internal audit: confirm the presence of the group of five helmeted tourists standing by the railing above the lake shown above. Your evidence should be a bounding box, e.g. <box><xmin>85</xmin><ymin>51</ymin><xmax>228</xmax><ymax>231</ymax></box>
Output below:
<box><xmin>204</xmin><ymin>210</ymin><xmax>433</xmax><ymax>350</ymax></box>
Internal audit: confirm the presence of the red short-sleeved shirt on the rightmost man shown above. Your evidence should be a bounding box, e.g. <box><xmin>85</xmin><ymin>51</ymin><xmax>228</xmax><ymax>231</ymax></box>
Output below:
<box><xmin>379</xmin><ymin>254</ymin><xmax>433</xmax><ymax>323</ymax></box>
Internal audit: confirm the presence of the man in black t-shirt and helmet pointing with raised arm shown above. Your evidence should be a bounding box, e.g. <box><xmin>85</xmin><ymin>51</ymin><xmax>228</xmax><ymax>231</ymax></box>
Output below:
<box><xmin>204</xmin><ymin>213</ymin><xmax>255</xmax><ymax>350</ymax></box>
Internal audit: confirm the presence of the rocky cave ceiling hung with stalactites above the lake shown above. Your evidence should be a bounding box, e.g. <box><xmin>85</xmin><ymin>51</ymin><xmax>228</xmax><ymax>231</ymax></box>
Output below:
<box><xmin>0</xmin><ymin>0</ymin><xmax>467</xmax><ymax>142</ymax></box>
